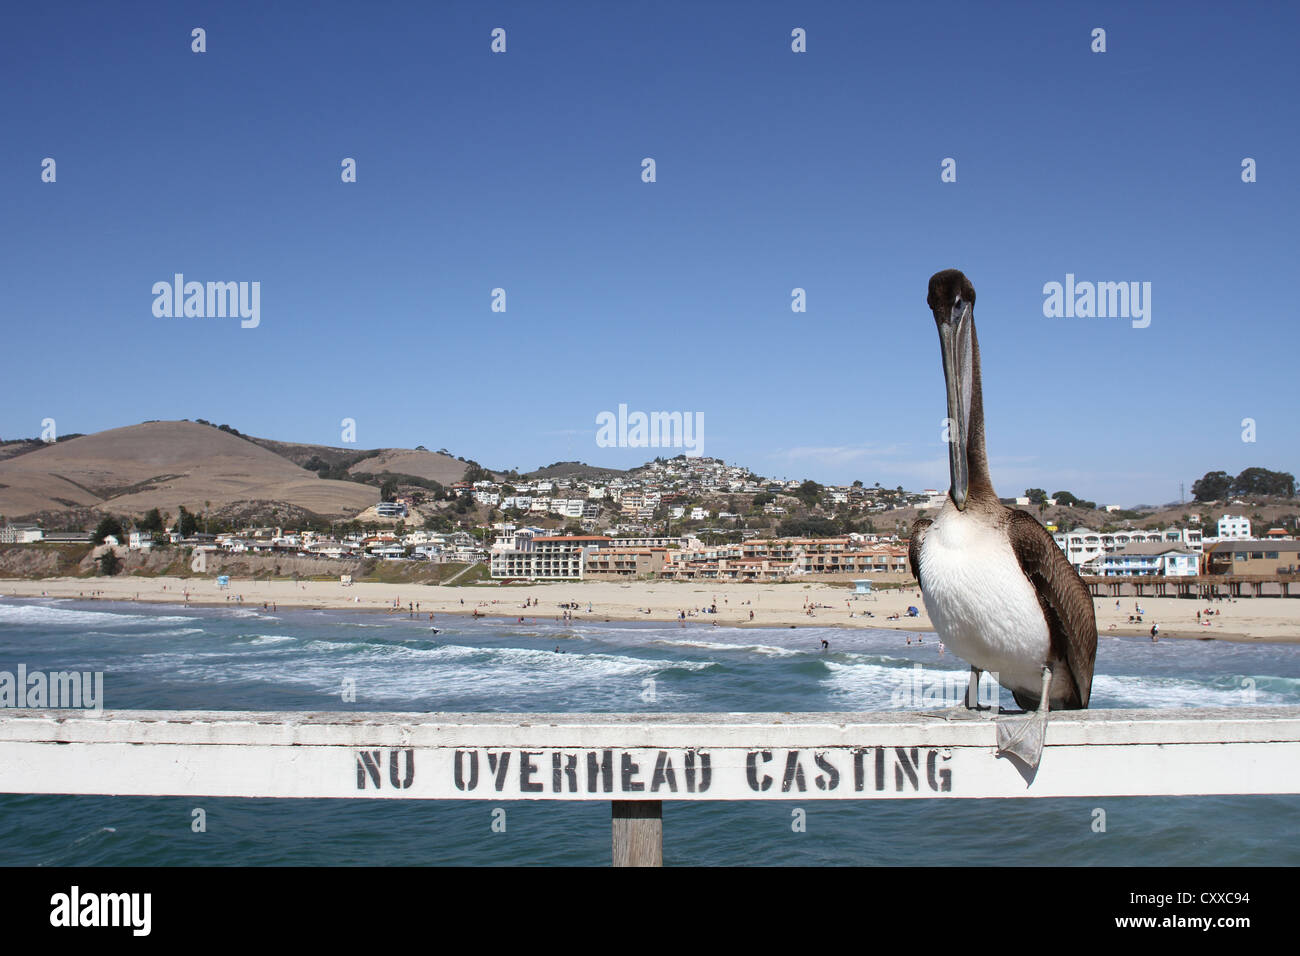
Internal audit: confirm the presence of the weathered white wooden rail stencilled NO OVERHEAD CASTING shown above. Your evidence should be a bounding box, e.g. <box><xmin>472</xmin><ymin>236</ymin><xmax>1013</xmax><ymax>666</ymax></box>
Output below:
<box><xmin>0</xmin><ymin>708</ymin><xmax>1300</xmax><ymax>800</ymax></box>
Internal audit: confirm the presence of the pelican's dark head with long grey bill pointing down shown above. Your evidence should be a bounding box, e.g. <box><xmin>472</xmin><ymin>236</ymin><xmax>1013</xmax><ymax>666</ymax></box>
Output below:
<box><xmin>926</xmin><ymin>269</ymin><xmax>975</xmax><ymax>511</ymax></box>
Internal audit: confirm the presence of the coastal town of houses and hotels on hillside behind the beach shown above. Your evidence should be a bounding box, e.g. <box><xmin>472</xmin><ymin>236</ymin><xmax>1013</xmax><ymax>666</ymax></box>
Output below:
<box><xmin>0</xmin><ymin>455</ymin><xmax>1300</xmax><ymax>596</ymax></box>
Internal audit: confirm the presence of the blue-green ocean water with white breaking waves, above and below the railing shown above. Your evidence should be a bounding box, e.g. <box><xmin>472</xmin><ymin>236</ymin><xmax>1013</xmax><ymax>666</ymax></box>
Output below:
<box><xmin>0</xmin><ymin>600</ymin><xmax>1300</xmax><ymax>866</ymax></box>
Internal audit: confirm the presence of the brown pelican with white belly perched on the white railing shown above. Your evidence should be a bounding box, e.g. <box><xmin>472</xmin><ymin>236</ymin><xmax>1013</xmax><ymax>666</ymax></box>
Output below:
<box><xmin>909</xmin><ymin>269</ymin><xmax>1097</xmax><ymax>770</ymax></box>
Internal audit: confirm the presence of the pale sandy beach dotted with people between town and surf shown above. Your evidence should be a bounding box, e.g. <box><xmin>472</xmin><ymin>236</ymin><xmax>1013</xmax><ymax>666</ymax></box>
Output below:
<box><xmin>0</xmin><ymin>578</ymin><xmax>1300</xmax><ymax>644</ymax></box>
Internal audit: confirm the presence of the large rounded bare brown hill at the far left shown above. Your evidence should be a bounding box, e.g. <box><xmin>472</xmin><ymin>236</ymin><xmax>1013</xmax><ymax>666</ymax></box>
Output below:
<box><xmin>0</xmin><ymin>421</ymin><xmax>378</xmax><ymax>518</ymax></box>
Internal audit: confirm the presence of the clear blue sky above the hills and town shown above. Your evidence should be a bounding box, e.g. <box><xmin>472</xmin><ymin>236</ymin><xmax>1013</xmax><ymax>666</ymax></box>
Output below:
<box><xmin>0</xmin><ymin>3</ymin><xmax>1300</xmax><ymax>505</ymax></box>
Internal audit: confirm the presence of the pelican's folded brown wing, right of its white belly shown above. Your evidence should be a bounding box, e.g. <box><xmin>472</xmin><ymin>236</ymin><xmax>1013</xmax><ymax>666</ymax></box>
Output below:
<box><xmin>1008</xmin><ymin>511</ymin><xmax>1097</xmax><ymax>710</ymax></box>
